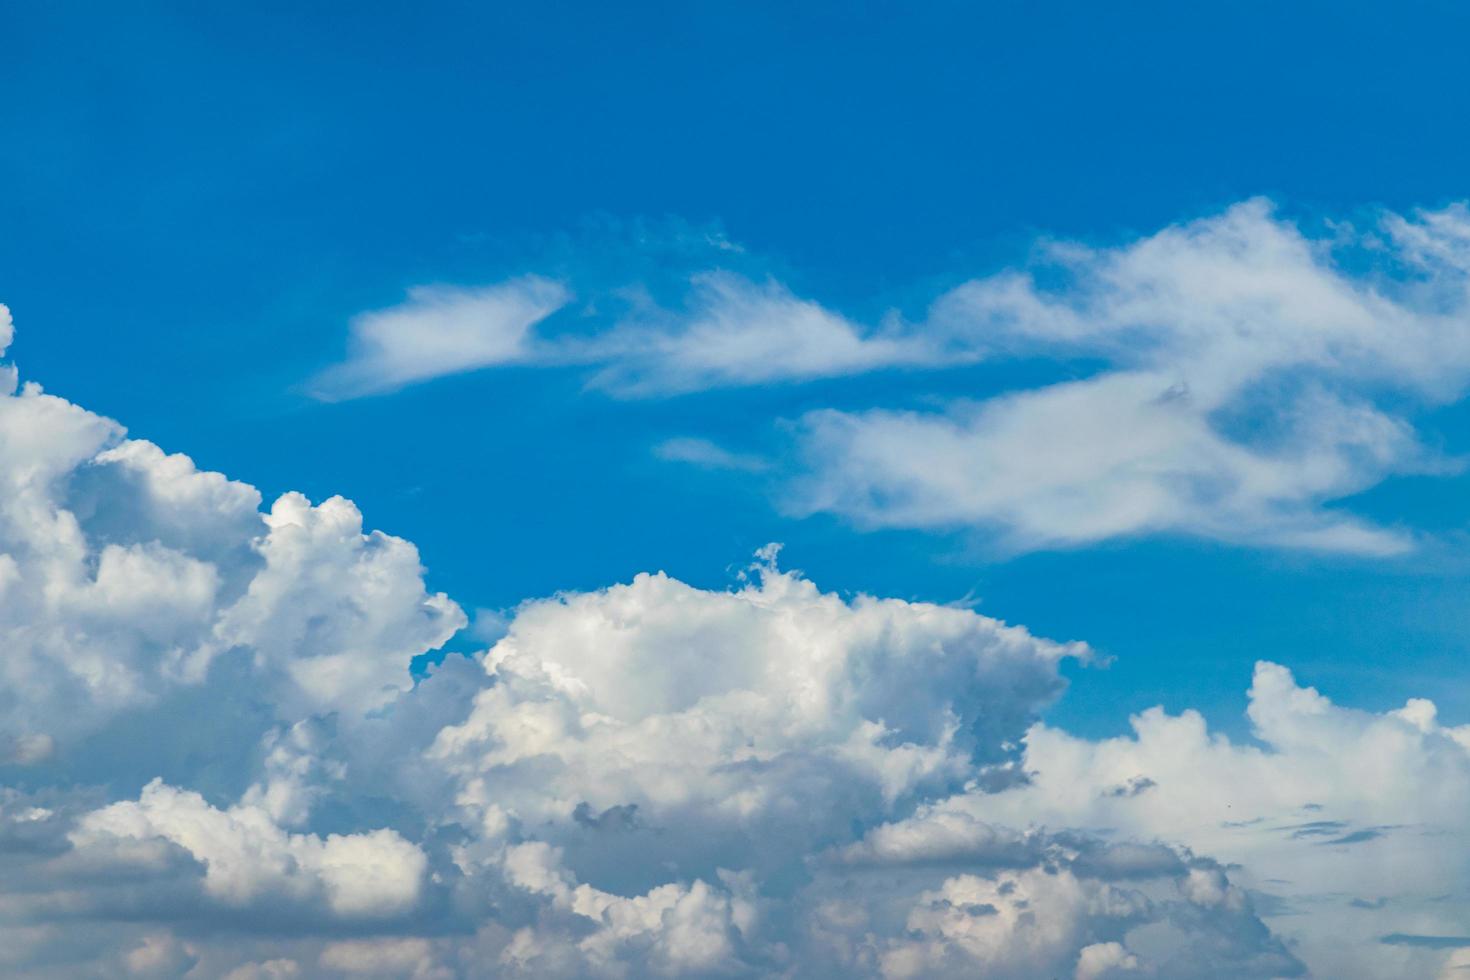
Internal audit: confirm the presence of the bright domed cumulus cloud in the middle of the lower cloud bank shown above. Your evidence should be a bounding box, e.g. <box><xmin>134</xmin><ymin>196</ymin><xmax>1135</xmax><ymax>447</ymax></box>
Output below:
<box><xmin>432</xmin><ymin>552</ymin><xmax>1085</xmax><ymax>871</ymax></box>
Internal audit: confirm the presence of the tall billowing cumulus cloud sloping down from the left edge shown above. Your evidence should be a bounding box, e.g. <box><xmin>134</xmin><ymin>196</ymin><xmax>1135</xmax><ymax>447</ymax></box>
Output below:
<box><xmin>0</xmin><ymin>376</ymin><xmax>465</xmax><ymax>761</ymax></box>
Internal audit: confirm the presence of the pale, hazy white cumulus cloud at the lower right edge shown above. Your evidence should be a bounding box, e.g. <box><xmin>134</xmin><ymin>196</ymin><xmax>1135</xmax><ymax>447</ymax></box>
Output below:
<box><xmin>861</xmin><ymin>663</ymin><xmax>1470</xmax><ymax>977</ymax></box>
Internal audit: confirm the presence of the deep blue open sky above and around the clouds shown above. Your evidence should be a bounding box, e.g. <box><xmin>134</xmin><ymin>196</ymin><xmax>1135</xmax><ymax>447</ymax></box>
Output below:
<box><xmin>0</xmin><ymin>3</ymin><xmax>1470</xmax><ymax>743</ymax></box>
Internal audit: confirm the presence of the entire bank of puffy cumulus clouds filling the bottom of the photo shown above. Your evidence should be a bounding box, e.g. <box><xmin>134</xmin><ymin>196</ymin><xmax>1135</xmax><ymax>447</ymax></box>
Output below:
<box><xmin>0</xmin><ymin>315</ymin><xmax>1470</xmax><ymax>980</ymax></box>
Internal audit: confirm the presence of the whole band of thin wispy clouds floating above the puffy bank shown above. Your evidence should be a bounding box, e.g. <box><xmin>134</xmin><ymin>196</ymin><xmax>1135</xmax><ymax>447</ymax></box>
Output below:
<box><xmin>320</xmin><ymin>200</ymin><xmax>1470</xmax><ymax>555</ymax></box>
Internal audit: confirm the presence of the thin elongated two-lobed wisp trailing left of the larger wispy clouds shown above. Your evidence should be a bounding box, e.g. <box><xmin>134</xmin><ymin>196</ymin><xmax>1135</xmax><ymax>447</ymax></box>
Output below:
<box><xmin>312</xmin><ymin>270</ymin><xmax>960</xmax><ymax>401</ymax></box>
